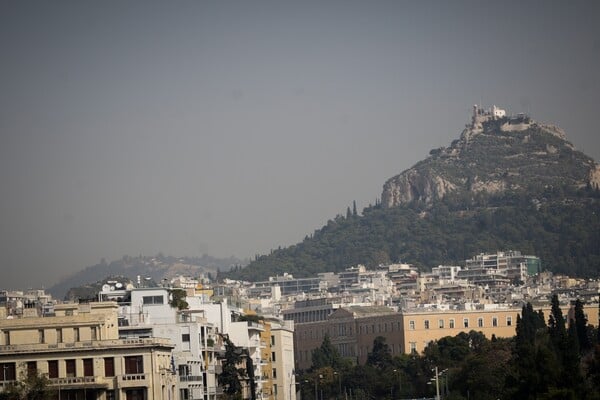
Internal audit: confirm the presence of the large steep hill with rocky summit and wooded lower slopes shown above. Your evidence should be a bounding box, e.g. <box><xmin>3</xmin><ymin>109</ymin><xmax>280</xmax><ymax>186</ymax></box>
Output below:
<box><xmin>229</xmin><ymin>107</ymin><xmax>600</xmax><ymax>280</ymax></box>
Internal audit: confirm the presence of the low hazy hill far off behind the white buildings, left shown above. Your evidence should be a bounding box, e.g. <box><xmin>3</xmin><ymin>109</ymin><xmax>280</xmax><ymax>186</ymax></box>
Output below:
<box><xmin>47</xmin><ymin>254</ymin><xmax>247</xmax><ymax>298</ymax></box>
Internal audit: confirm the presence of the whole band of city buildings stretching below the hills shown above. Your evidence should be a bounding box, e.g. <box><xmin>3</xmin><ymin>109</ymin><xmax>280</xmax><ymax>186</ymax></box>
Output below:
<box><xmin>0</xmin><ymin>250</ymin><xmax>600</xmax><ymax>400</ymax></box>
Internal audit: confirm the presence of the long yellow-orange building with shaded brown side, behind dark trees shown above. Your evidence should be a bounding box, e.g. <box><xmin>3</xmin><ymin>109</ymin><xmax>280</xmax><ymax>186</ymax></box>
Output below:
<box><xmin>294</xmin><ymin>304</ymin><xmax>598</xmax><ymax>370</ymax></box>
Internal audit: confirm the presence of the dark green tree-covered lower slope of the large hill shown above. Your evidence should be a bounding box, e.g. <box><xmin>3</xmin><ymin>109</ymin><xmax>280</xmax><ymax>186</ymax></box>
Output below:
<box><xmin>228</xmin><ymin>191</ymin><xmax>600</xmax><ymax>280</ymax></box>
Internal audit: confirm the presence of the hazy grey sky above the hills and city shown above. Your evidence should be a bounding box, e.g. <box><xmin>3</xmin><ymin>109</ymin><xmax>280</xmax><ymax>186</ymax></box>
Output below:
<box><xmin>0</xmin><ymin>0</ymin><xmax>600</xmax><ymax>288</ymax></box>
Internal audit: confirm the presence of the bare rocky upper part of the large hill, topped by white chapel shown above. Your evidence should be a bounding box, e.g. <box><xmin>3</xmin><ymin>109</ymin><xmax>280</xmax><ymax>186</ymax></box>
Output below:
<box><xmin>381</xmin><ymin>106</ymin><xmax>600</xmax><ymax>208</ymax></box>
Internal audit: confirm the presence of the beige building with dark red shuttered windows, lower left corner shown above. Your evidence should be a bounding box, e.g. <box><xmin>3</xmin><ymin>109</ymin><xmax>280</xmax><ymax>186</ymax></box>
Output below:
<box><xmin>0</xmin><ymin>302</ymin><xmax>178</xmax><ymax>400</ymax></box>
